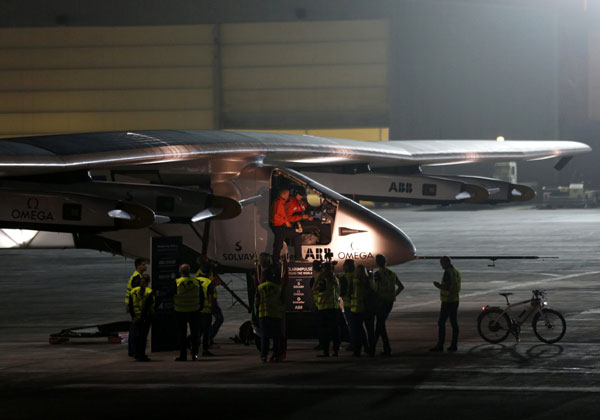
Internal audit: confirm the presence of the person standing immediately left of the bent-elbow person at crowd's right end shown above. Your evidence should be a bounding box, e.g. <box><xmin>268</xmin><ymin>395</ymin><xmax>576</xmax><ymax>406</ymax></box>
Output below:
<box><xmin>349</xmin><ymin>265</ymin><xmax>376</xmax><ymax>357</ymax></box>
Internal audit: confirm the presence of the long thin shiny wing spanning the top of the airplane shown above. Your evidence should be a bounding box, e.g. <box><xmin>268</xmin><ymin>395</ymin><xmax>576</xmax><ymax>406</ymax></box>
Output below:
<box><xmin>0</xmin><ymin>131</ymin><xmax>591</xmax><ymax>177</ymax></box>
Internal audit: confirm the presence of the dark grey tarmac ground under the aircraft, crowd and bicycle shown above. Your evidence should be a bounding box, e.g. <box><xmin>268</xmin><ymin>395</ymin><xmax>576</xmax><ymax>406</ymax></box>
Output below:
<box><xmin>0</xmin><ymin>206</ymin><xmax>600</xmax><ymax>419</ymax></box>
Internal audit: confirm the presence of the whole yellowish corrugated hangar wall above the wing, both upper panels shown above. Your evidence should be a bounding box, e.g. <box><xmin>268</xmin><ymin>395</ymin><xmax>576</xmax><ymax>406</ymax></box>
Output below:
<box><xmin>0</xmin><ymin>20</ymin><xmax>389</xmax><ymax>137</ymax></box>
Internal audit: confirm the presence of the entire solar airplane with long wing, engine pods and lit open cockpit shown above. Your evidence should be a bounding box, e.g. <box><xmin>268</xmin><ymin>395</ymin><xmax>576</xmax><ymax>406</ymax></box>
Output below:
<box><xmin>0</xmin><ymin>131</ymin><xmax>591</xmax><ymax>272</ymax></box>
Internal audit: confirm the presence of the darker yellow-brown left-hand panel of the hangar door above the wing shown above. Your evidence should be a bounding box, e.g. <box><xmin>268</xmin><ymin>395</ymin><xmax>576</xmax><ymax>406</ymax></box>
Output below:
<box><xmin>0</xmin><ymin>25</ymin><xmax>213</xmax><ymax>137</ymax></box>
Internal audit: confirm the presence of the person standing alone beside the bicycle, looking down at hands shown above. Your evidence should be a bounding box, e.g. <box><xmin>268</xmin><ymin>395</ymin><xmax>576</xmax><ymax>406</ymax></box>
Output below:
<box><xmin>431</xmin><ymin>257</ymin><xmax>461</xmax><ymax>352</ymax></box>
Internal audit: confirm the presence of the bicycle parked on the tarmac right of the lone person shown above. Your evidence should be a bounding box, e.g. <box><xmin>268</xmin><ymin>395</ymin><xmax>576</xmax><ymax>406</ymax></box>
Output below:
<box><xmin>477</xmin><ymin>290</ymin><xmax>567</xmax><ymax>344</ymax></box>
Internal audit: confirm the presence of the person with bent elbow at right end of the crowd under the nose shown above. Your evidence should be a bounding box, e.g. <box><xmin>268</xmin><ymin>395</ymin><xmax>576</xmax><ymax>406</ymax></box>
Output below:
<box><xmin>373</xmin><ymin>254</ymin><xmax>404</xmax><ymax>356</ymax></box>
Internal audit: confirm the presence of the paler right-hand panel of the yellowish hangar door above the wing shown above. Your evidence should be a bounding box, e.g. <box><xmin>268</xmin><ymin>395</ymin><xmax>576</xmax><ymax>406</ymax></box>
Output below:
<box><xmin>221</xmin><ymin>20</ymin><xmax>389</xmax><ymax>129</ymax></box>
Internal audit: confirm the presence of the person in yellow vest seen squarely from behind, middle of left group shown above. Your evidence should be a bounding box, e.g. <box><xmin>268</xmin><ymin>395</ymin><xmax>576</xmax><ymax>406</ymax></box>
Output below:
<box><xmin>174</xmin><ymin>264</ymin><xmax>204</xmax><ymax>362</ymax></box>
